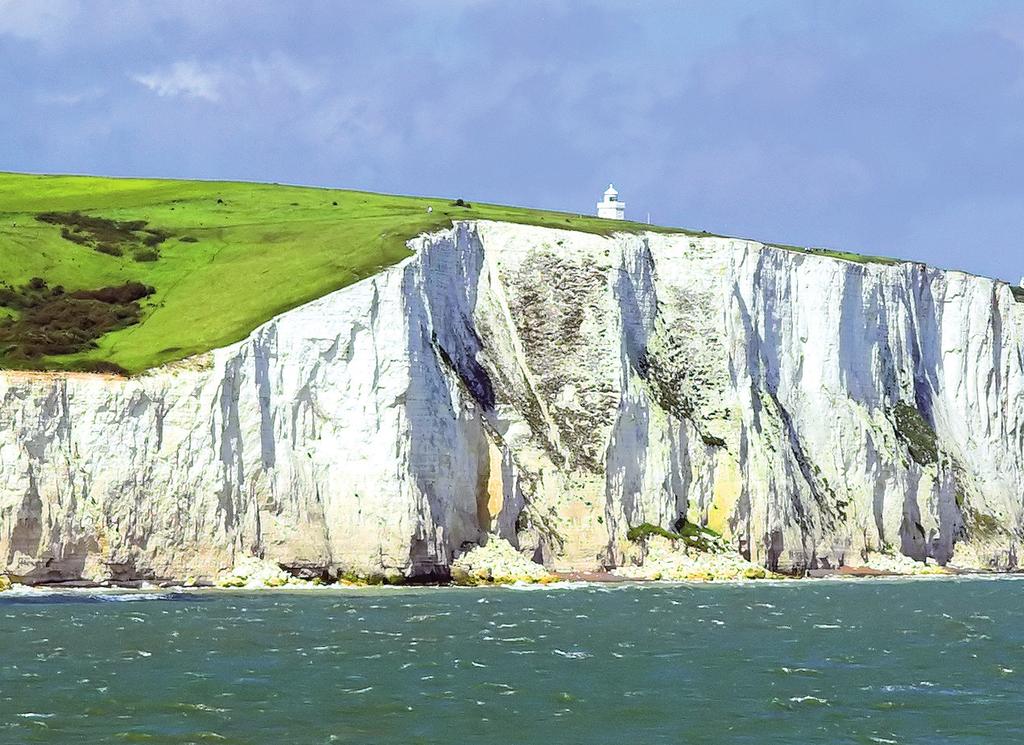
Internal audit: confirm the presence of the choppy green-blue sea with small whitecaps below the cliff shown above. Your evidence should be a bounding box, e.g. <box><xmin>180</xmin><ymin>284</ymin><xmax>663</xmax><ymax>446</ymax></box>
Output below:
<box><xmin>0</xmin><ymin>577</ymin><xmax>1024</xmax><ymax>745</ymax></box>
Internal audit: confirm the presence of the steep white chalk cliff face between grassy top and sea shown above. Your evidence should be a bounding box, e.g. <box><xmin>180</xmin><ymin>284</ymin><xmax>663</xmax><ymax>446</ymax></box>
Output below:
<box><xmin>0</xmin><ymin>223</ymin><xmax>1024</xmax><ymax>581</ymax></box>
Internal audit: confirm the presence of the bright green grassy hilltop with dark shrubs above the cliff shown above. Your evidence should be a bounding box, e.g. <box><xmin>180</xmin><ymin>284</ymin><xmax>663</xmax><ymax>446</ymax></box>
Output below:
<box><xmin>0</xmin><ymin>173</ymin><xmax>666</xmax><ymax>373</ymax></box>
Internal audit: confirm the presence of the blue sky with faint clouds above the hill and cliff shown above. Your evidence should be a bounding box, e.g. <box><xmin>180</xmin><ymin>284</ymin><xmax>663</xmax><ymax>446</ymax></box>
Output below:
<box><xmin>0</xmin><ymin>0</ymin><xmax>1024</xmax><ymax>280</ymax></box>
